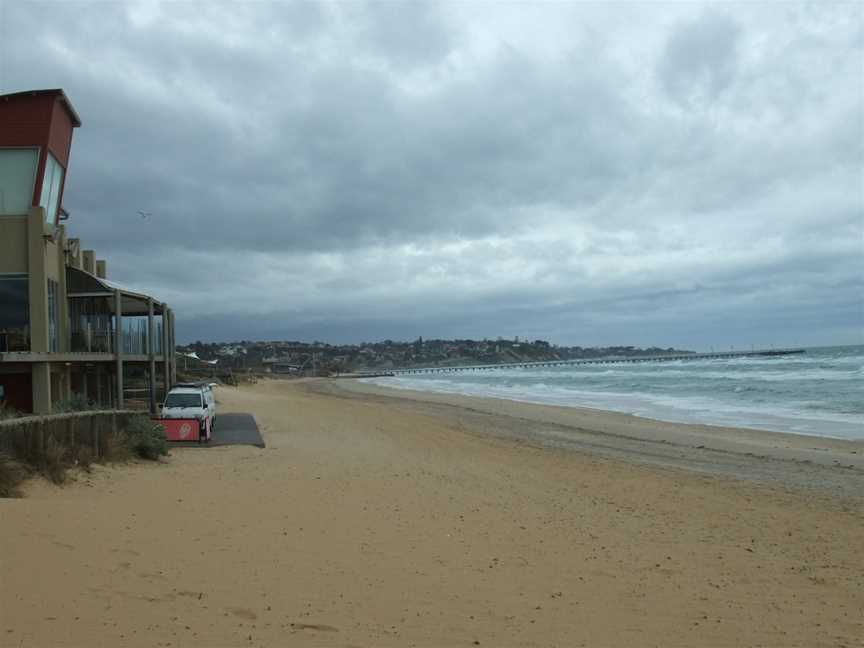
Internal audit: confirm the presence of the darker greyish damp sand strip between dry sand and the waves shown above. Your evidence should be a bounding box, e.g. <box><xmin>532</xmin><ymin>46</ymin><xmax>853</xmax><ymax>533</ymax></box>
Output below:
<box><xmin>318</xmin><ymin>379</ymin><xmax>864</xmax><ymax>498</ymax></box>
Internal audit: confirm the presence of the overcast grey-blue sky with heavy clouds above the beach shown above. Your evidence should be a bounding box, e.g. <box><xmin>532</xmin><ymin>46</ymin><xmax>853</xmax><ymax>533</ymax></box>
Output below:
<box><xmin>0</xmin><ymin>0</ymin><xmax>864</xmax><ymax>349</ymax></box>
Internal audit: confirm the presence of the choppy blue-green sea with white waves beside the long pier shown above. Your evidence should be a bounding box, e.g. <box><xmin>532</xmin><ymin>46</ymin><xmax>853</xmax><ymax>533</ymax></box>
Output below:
<box><xmin>370</xmin><ymin>346</ymin><xmax>864</xmax><ymax>440</ymax></box>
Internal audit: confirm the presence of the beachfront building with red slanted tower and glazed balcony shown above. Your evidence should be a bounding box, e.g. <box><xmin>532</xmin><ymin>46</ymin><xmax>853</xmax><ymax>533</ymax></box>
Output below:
<box><xmin>0</xmin><ymin>90</ymin><xmax>176</xmax><ymax>413</ymax></box>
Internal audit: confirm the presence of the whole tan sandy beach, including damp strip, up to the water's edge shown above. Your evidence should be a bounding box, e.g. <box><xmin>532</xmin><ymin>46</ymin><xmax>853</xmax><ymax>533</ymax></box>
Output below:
<box><xmin>0</xmin><ymin>381</ymin><xmax>864</xmax><ymax>647</ymax></box>
